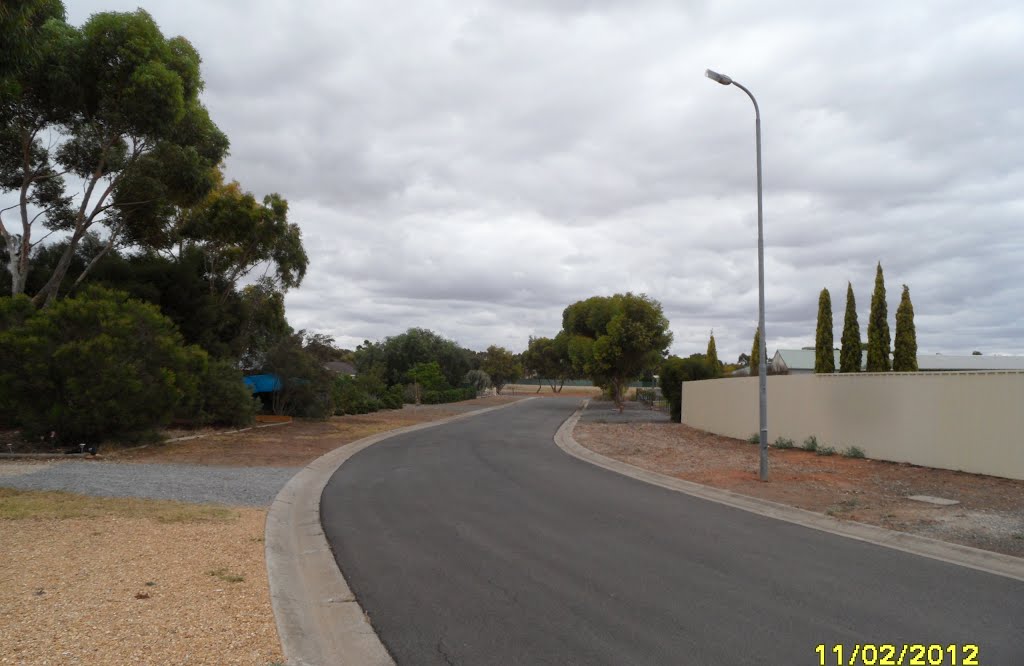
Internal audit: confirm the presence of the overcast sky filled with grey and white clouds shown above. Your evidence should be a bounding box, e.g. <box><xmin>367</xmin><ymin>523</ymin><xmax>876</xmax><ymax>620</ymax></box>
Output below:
<box><xmin>68</xmin><ymin>0</ymin><xmax>1024</xmax><ymax>360</ymax></box>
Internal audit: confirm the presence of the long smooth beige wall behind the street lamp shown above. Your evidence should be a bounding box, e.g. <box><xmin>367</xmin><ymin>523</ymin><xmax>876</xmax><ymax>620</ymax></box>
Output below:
<box><xmin>683</xmin><ymin>372</ymin><xmax>1024</xmax><ymax>480</ymax></box>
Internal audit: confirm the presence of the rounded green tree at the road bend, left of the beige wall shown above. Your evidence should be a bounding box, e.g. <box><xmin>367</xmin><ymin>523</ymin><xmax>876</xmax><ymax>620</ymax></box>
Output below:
<box><xmin>562</xmin><ymin>293</ymin><xmax>672</xmax><ymax>408</ymax></box>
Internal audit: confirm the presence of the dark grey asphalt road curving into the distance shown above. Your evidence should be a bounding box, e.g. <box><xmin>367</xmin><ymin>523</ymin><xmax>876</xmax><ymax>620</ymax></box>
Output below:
<box><xmin>322</xmin><ymin>400</ymin><xmax>1024</xmax><ymax>666</ymax></box>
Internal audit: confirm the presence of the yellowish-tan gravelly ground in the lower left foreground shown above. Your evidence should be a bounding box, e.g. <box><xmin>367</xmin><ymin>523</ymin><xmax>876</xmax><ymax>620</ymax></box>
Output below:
<box><xmin>0</xmin><ymin>500</ymin><xmax>284</xmax><ymax>665</ymax></box>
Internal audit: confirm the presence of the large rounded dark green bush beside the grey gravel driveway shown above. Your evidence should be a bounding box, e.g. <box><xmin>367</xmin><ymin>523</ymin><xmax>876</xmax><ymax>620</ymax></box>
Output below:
<box><xmin>0</xmin><ymin>288</ymin><xmax>207</xmax><ymax>444</ymax></box>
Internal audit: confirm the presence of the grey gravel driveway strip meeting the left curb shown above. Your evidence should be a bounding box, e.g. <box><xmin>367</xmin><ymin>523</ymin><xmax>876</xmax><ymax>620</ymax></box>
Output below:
<box><xmin>0</xmin><ymin>460</ymin><xmax>300</xmax><ymax>506</ymax></box>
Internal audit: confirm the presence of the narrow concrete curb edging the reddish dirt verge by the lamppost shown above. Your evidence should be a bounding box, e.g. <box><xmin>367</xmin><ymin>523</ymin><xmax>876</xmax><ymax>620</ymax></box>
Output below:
<box><xmin>555</xmin><ymin>404</ymin><xmax>1024</xmax><ymax>582</ymax></box>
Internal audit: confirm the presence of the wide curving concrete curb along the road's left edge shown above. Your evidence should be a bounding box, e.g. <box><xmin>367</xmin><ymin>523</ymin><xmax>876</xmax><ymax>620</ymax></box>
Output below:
<box><xmin>265</xmin><ymin>398</ymin><xmax>534</xmax><ymax>666</ymax></box>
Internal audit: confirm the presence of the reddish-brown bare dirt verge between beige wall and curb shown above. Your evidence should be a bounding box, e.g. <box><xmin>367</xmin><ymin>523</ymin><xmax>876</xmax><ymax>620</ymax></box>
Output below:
<box><xmin>573</xmin><ymin>422</ymin><xmax>1024</xmax><ymax>557</ymax></box>
